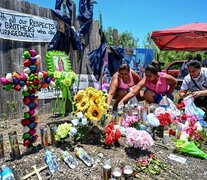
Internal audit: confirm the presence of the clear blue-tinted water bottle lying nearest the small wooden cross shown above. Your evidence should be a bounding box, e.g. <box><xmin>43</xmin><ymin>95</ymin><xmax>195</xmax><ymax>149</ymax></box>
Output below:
<box><xmin>45</xmin><ymin>149</ymin><xmax>59</xmax><ymax>174</ymax></box>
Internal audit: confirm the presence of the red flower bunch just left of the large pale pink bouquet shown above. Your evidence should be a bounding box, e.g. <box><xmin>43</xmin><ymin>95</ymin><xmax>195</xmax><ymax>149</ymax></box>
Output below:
<box><xmin>105</xmin><ymin>123</ymin><xmax>121</xmax><ymax>145</ymax></box>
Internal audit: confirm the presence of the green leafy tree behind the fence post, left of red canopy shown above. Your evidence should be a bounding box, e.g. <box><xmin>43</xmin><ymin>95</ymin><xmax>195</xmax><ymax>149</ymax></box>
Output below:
<box><xmin>104</xmin><ymin>27</ymin><xmax>139</xmax><ymax>48</ymax></box>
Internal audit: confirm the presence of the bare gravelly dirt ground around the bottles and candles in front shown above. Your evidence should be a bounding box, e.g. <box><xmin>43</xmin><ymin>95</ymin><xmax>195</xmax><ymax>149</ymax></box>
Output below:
<box><xmin>0</xmin><ymin>114</ymin><xmax>207</xmax><ymax>180</ymax></box>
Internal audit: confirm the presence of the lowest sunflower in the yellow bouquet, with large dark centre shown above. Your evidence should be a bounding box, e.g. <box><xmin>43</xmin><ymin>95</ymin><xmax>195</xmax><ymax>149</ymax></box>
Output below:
<box><xmin>86</xmin><ymin>105</ymin><xmax>102</xmax><ymax>121</ymax></box>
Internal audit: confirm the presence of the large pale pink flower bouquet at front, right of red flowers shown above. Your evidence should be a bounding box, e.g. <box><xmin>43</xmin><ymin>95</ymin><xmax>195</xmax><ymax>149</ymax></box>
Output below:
<box><xmin>126</xmin><ymin>127</ymin><xmax>154</xmax><ymax>150</ymax></box>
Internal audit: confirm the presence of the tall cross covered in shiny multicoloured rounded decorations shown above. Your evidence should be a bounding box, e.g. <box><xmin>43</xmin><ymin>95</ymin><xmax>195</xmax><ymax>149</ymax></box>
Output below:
<box><xmin>0</xmin><ymin>50</ymin><xmax>55</xmax><ymax>147</ymax></box>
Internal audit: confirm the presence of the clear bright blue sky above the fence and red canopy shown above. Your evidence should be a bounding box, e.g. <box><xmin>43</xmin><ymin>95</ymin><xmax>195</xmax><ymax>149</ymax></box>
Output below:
<box><xmin>27</xmin><ymin>0</ymin><xmax>207</xmax><ymax>47</ymax></box>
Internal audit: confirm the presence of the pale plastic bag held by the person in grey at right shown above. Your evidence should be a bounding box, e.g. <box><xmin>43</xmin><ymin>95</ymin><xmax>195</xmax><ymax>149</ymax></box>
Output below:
<box><xmin>183</xmin><ymin>96</ymin><xmax>205</xmax><ymax>119</ymax></box>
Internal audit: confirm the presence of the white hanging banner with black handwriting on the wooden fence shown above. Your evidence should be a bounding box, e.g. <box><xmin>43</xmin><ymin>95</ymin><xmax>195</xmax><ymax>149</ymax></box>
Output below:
<box><xmin>0</xmin><ymin>8</ymin><xmax>57</xmax><ymax>42</ymax></box>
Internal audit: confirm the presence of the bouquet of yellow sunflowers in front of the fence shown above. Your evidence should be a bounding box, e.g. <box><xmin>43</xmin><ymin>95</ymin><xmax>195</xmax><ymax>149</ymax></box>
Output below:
<box><xmin>73</xmin><ymin>87</ymin><xmax>108</xmax><ymax>121</ymax></box>
